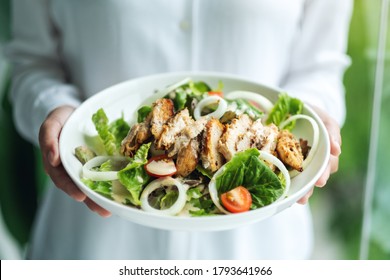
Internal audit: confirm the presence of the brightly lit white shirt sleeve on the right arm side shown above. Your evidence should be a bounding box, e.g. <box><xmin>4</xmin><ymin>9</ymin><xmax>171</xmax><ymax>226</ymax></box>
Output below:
<box><xmin>281</xmin><ymin>0</ymin><xmax>353</xmax><ymax>125</ymax></box>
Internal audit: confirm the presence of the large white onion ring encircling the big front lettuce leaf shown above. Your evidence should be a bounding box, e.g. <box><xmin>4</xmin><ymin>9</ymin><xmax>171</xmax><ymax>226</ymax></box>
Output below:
<box><xmin>209</xmin><ymin>151</ymin><xmax>291</xmax><ymax>214</ymax></box>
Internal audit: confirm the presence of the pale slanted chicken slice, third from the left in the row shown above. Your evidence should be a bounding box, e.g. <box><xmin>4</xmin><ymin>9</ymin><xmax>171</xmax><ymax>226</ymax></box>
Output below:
<box><xmin>156</xmin><ymin>108</ymin><xmax>194</xmax><ymax>150</ymax></box>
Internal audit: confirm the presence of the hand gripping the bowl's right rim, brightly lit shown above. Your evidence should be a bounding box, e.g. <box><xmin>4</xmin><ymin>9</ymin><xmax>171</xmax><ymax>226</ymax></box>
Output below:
<box><xmin>298</xmin><ymin>106</ymin><xmax>341</xmax><ymax>204</ymax></box>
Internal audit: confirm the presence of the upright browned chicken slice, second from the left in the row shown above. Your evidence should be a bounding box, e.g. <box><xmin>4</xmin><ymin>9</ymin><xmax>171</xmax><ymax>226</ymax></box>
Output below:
<box><xmin>150</xmin><ymin>98</ymin><xmax>174</xmax><ymax>139</ymax></box>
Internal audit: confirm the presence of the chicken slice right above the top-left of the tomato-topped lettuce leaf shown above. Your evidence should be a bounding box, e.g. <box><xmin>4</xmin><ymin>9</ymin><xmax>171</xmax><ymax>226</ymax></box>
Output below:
<box><xmin>218</xmin><ymin>114</ymin><xmax>252</xmax><ymax>161</ymax></box>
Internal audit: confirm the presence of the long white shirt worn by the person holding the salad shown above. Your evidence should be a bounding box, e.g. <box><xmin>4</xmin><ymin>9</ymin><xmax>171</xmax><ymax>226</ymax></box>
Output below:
<box><xmin>7</xmin><ymin>0</ymin><xmax>352</xmax><ymax>259</ymax></box>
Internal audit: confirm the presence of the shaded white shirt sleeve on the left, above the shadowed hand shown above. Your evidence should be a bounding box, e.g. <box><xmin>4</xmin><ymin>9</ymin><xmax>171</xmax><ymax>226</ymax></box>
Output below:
<box><xmin>5</xmin><ymin>0</ymin><xmax>80</xmax><ymax>147</ymax></box>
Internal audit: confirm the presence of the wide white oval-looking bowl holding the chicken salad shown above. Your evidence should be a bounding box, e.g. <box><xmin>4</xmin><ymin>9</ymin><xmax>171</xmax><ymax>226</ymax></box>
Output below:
<box><xmin>60</xmin><ymin>72</ymin><xmax>330</xmax><ymax>231</ymax></box>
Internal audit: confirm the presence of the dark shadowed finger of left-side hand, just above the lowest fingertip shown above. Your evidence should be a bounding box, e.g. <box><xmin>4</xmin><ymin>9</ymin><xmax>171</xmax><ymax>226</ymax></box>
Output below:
<box><xmin>48</xmin><ymin>165</ymin><xmax>86</xmax><ymax>202</ymax></box>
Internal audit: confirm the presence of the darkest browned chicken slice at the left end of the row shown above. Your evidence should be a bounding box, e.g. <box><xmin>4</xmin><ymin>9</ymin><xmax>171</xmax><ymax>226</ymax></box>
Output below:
<box><xmin>121</xmin><ymin>114</ymin><xmax>152</xmax><ymax>157</ymax></box>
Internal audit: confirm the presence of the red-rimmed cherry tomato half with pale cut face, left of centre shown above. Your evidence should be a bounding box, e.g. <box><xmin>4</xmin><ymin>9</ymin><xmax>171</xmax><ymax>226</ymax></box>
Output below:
<box><xmin>144</xmin><ymin>155</ymin><xmax>177</xmax><ymax>177</ymax></box>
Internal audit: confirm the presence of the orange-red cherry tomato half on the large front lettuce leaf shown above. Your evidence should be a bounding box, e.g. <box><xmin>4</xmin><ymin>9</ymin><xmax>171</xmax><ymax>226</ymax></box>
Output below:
<box><xmin>221</xmin><ymin>186</ymin><xmax>252</xmax><ymax>213</ymax></box>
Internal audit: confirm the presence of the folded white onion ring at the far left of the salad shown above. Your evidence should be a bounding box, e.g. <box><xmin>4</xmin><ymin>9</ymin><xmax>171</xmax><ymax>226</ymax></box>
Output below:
<box><xmin>82</xmin><ymin>156</ymin><xmax>129</xmax><ymax>181</ymax></box>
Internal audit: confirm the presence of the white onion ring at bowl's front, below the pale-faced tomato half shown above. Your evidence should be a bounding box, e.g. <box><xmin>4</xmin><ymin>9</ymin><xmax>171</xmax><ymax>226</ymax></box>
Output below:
<box><xmin>140</xmin><ymin>177</ymin><xmax>187</xmax><ymax>216</ymax></box>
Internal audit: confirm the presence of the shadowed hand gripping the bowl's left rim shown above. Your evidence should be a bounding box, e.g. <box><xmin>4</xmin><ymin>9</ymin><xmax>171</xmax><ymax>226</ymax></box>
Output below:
<box><xmin>39</xmin><ymin>106</ymin><xmax>111</xmax><ymax>217</ymax></box>
